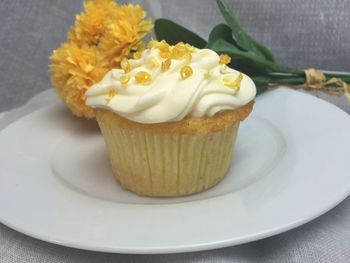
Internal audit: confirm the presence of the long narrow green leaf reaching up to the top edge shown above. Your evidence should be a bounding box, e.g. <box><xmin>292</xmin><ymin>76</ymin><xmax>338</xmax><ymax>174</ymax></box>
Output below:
<box><xmin>216</xmin><ymin>0</ymin><xmax>275</xmax><ymax>62</ymax></box>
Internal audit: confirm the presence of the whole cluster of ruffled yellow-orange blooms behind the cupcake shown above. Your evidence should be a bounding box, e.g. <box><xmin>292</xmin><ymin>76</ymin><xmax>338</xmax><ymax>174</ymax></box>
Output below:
<box><xmin>50</xmin><ymin>0</ymin><xmax>153</xmax><ymax>118</ymax></box>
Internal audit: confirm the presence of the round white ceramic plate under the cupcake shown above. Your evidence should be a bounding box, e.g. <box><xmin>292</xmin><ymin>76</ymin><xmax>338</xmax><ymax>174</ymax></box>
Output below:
<box><xmin>0</xmin><ymin>89</ymin><xmax>350</xmax><ymax>253</ymax></box>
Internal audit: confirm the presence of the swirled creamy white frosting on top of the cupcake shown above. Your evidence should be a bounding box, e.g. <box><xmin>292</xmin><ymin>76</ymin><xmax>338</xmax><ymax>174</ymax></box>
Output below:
<box><xmin>85</xmin><ymin>48</ymin><xmax>256</xmax><ymax>123</ymax></box>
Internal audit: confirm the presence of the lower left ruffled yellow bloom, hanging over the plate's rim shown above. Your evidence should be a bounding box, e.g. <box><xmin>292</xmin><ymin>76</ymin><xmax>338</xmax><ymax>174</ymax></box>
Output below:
<box><xmin>50</xmin><ymin>43</ymin><xmax>108</xmax><ymax>118</ymax></box>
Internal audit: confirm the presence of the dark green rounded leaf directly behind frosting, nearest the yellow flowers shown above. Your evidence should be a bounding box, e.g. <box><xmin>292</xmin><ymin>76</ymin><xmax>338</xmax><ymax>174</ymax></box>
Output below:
<box><xmin>154</xmin><ymin>18</ymin><xmax>207</xmax><ymax>48</ymax></box>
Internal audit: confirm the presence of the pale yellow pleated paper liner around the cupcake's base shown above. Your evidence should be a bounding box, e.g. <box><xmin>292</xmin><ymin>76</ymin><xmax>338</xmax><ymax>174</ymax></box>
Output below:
<box><xmin>97</xmin><ymin>117</ymin><xmax>239</xmax><ymax>197</ymax></box>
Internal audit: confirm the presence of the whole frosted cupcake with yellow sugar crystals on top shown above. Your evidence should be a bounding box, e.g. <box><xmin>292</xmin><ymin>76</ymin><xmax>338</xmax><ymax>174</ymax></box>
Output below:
<box><xmin>85</xmin><ymin>41</ymin><xmax>256</xmax><ymax>197</ymax></box>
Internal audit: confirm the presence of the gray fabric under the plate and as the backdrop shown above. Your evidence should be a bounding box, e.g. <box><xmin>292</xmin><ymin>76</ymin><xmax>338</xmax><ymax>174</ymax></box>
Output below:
<box><xmin>0</xmin><ymin>0</ymin><xmax>350</xmax><ymax>263</ymax></box>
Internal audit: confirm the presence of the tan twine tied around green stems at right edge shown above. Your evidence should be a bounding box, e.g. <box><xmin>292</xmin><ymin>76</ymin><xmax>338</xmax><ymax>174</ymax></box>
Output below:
<box><xmin>291</xmin><ymin>68</ymin><xmax>350</xmax><ymax>103</ymax></box>
